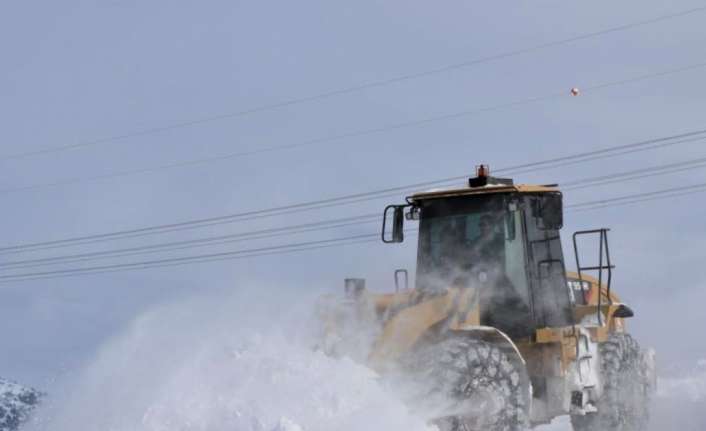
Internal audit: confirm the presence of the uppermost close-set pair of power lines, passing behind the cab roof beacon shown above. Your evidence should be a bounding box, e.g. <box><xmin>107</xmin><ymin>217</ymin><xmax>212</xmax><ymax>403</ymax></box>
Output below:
<box><xmin>0</xmin><ymin>129</ymin><xmax>706</xmax><ymax>254</ymax></box>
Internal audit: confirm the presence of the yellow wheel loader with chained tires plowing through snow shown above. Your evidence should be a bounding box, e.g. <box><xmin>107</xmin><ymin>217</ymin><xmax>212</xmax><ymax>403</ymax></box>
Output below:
<box><xmin>319</xmin><ymin>165</ymin><xmax>655</xmax><ymax>431</ymax></box>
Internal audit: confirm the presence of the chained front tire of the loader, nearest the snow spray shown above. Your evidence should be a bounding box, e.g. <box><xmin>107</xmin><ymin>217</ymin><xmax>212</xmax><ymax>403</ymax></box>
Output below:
<box><xmin>404</xmin><ymin>336</ymin><xmax>530</xmax><ymax>431</ymax></box>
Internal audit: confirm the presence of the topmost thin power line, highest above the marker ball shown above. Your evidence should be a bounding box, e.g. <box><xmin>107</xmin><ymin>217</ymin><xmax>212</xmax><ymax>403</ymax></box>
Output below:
<box><xmin>0</xmin><ymin>7</ymin><xmax>706</xmax><ymax>161</ymax></box>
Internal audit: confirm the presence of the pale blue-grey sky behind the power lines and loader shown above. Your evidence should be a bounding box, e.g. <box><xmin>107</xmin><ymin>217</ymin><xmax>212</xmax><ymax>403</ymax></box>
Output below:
<box><xmin>0</xmin><ymin>0</ymin><xmax>706</xmax><ymax>386</ymax></box>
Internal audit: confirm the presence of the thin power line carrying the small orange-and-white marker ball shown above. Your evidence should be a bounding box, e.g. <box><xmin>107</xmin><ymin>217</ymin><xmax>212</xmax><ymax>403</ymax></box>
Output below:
<box><xmin>0</xmin><ymin>62</ymin><xmax>706</xmax><ymax>194</ymax></box>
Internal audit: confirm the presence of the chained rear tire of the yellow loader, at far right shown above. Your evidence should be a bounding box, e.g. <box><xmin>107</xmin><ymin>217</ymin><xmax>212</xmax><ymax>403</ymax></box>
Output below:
<box><xmin>571</xmin><ymin>333</ymin><xmax>650</xmax><ymax>431</ymax></box>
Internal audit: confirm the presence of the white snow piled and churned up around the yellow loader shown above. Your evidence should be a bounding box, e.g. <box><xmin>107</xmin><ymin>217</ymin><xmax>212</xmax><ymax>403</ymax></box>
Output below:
<box><xmin>13</xmin><ymin>297</ymin><xmax>706</xmax><ymax>431</ymax></box>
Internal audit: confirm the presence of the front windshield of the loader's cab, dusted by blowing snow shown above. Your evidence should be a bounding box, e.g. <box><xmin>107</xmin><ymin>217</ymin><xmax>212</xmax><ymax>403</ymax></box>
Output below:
<box><xmin>417</xmin><ymin>195</ymin><xmax>529</xmax><ymax>303</ymax></box>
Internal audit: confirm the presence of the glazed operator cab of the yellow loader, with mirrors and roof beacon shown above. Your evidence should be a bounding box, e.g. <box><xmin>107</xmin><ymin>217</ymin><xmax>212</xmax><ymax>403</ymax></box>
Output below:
<box><xmin>383</xmin><ymin>166</ymin><xmax>573</xmax><ymax>338</ymax></box>
